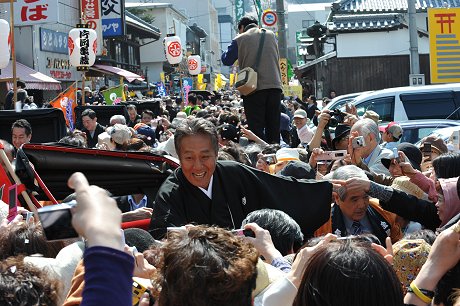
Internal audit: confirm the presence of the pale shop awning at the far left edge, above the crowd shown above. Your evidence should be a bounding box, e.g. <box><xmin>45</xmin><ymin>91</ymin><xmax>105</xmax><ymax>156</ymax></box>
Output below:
<box><xmin>0</xmin><ymin>61</ymin><xmax>61</xmax><ymax>90</ymax></box>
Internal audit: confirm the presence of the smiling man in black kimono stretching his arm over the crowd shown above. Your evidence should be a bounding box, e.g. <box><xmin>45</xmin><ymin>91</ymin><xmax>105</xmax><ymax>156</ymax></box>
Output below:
<box><xmin>150</xmin><ymin>119</ymin><xmax>332</xmax><ymax>239</ymax></box>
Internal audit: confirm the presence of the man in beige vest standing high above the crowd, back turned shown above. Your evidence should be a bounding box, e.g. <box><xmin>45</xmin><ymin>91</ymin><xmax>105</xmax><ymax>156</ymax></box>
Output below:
<box><xmin>222</xmin><ymin>16</ymin><xmax>282</xmax><ymax>143</ymax></box>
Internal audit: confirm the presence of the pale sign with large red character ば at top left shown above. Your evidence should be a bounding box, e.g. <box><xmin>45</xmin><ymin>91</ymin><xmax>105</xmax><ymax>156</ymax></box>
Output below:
<box><xmin>14</xmin><ymin>0</ymin><xmax>59</xmax><ymax>26</ymax></box>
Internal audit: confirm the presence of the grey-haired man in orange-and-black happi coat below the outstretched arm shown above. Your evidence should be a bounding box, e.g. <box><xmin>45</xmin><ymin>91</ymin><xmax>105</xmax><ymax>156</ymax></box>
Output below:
<box><xmin>315</xmin><ymin>165</ymin><xmax>402</xmax><ymax>245</ymax></box>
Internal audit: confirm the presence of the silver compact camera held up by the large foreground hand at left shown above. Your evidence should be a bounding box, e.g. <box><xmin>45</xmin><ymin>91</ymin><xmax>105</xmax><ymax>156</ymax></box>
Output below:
<box><xmin>37</xmin><ymin>201</ymin><xmax>78</xmax><ymax>240</ymax></box>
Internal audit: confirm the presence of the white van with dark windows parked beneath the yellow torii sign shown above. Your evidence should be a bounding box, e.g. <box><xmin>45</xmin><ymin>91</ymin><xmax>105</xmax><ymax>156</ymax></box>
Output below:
<box><xmin>353</xmin><ymin>83</ymin><xmax>460</xmax><ymax>122</ymax></box>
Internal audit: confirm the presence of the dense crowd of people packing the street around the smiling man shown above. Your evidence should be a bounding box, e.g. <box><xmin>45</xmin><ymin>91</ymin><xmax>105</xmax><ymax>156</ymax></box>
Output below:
<box><xmin>0</xmin><ymin>14</ymin><xmax>460</xmax><ymax>306</ymax></box>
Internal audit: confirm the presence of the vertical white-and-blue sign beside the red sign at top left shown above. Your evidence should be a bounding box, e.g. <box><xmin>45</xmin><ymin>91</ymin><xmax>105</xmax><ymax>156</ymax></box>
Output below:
<box><xmin>101</xmin><ymin>0</ymin><xmax>124</xmax><ymax>37</ymax></box>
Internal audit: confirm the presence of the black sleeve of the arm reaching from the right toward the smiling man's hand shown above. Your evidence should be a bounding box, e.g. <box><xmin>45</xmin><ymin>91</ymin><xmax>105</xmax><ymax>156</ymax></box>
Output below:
<box><xmin>380</xmin><ymin>189</ymin><xmax>441</xmax><ymax>231</ymax></box>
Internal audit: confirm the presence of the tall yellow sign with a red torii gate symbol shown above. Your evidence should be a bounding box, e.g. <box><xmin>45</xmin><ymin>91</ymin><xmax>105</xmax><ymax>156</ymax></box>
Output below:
<box><xmin>428</xmin><ymin>8</ymin><xmax>460</xmax><ymax>83</ymax></box>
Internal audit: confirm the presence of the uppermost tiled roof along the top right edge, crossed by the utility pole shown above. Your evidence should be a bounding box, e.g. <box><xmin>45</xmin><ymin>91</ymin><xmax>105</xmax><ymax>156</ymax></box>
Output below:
<box><xmin>333</xmin><ymin>0</ymin><xmax>460</xmax><ymax>14</ymax></box>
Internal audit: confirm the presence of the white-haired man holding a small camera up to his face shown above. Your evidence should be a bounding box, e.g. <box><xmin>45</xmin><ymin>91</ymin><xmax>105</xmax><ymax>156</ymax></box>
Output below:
<box><xmin>349</xmin><ymin>119</ymin><xmax>393</xmax><ymax>175</ymax></box>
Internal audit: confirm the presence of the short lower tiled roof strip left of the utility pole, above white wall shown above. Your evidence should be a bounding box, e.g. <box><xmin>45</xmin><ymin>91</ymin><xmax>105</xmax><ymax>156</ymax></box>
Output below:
<box><xmin>328</xmin><ymin>13</ymin><xmax>401</xmax><ymax>32</ymax></box>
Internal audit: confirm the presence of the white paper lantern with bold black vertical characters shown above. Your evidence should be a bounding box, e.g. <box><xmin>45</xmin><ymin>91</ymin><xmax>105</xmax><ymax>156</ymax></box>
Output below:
<box><xmin>67</xmin><ymin>28</ymin><xmax>97</xmax><ymax>70</ymax></box>
